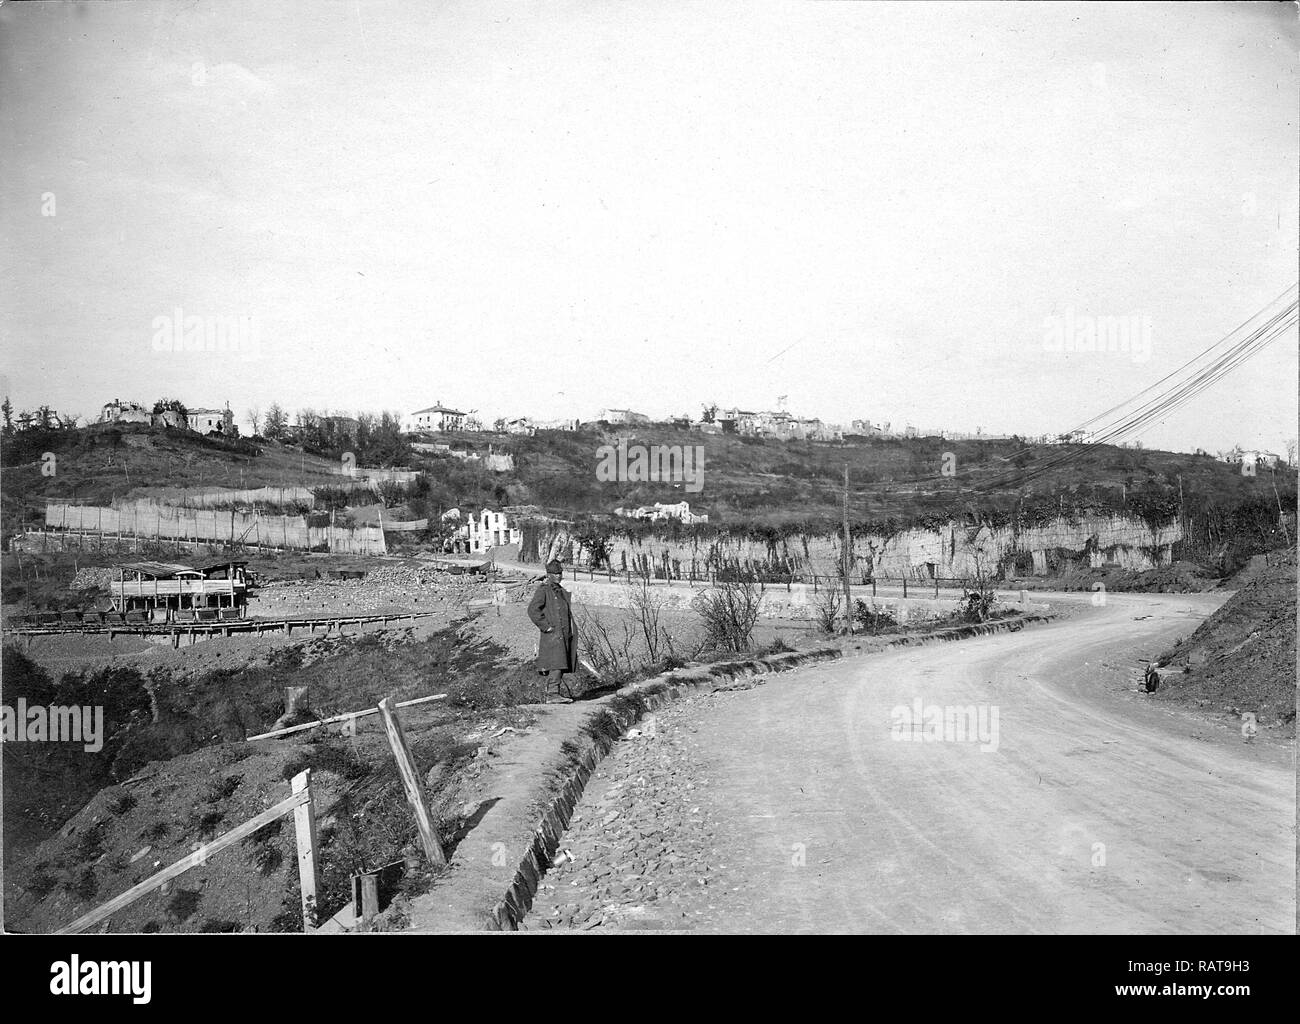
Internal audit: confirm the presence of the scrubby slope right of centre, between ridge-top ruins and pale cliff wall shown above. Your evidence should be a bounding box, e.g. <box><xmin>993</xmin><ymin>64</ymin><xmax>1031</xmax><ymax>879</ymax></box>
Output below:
<box><xmin>449</xmin><ymin>426</ymin><xmax>1295</xmax><ymax>524</ymax></box>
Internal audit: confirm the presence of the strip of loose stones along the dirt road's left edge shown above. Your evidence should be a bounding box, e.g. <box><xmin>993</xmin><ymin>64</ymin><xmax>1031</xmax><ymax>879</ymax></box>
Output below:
<box><xmin>523</xmin><ymin>684</ymin><xmax>745</xmax><ymax>932</ymax></box>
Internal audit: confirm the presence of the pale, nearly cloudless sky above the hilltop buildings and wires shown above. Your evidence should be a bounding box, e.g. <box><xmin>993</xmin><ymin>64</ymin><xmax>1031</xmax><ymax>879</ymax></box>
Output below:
<box><xmin>0</xmin><ymin>0</ymin><xmax>1300</xmax><ymax>452</ymax></box>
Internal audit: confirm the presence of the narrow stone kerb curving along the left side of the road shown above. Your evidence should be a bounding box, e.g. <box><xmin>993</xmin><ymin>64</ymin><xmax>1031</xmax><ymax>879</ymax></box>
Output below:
<box><xmin>485</xmin><ymin>615</ymin><xmax>1054</xmax><ymax>932</ymax></box>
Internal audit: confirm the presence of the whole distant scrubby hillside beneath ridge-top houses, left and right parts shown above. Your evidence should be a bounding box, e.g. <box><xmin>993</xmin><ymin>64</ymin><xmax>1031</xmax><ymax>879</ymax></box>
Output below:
<box><xmin>4</xmin><ymin>415</ymin><xmax>1296</xmax><ymax>572</ymax></box>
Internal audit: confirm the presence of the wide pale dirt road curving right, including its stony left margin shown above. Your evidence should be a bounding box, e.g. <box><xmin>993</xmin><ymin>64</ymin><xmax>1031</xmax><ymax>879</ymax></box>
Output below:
<box><xmin>527</xmin><ymin>594</ymin><xmax>1296</xmax><ymax>933</ymax></box>
